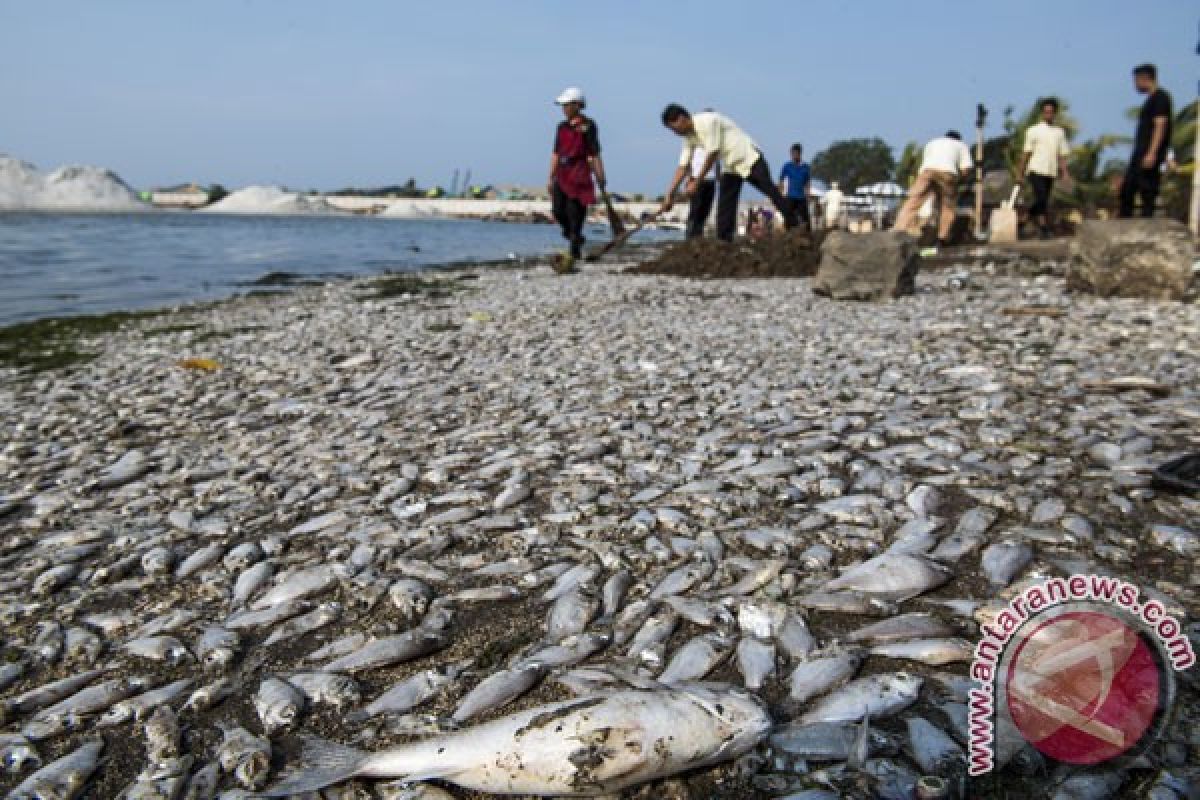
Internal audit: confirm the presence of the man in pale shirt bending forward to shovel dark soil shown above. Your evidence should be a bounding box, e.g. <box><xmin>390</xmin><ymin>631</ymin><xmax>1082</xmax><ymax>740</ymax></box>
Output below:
<box><xmin>660</xmin><ymin>103</ymin><xmax>799</xmax><ymax>241</ymax></box>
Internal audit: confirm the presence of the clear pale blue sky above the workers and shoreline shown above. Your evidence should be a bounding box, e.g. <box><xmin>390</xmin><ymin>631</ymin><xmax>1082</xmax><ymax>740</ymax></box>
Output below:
<box><xmin>0</xmin><ymin>0</ymin><xmax>1200</xmax><ymax>193</ymax></box>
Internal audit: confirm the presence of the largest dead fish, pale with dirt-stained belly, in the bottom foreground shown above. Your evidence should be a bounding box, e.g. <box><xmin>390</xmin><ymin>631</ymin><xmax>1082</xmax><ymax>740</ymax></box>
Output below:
<box><xmin>263</xmin><ymin>686</ymin><xmax>770</xmax><ymax>798</ymax></box>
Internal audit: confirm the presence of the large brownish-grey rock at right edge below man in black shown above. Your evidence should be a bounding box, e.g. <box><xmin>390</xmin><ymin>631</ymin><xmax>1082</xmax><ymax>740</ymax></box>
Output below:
<box><xmin>1067</xmin><ymin>219</ymin><xmax>1195</xmax><ymax>300</ymax></box>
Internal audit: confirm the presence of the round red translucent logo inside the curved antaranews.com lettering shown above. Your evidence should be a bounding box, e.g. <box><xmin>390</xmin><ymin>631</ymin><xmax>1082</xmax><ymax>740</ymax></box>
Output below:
<box><xmin>1004</xmin><ymin>610</ymin><xmax>1163</xmax><ymax>764</ymax></box>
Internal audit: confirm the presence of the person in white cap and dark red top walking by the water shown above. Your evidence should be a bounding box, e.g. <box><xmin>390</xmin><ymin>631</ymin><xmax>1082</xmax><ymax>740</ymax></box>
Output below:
<box><xmin>547</xmin><ymin>86</ymin><xmax>605</xmax><ymax>258</ymax></box>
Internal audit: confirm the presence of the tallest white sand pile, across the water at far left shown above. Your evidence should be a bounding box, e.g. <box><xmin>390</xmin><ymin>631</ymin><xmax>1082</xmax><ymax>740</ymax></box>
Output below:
<box><xmin>0</xmin><ymin>155</ymin><xmax>150</xmax><ymax>211</ymax></box>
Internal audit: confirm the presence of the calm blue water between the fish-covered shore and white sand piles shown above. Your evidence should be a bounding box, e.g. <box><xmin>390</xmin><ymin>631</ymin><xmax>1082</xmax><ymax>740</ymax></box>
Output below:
<box><xmin>0</xmin><ymin>212</ymin><xmax>664</xmax><ymax>325</ymax></box>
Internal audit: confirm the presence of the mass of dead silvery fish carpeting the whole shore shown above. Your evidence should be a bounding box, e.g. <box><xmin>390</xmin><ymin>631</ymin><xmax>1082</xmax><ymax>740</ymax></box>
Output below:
<box><xmin>0</xmin><ymin>257</ymin><xmax>1200</xmax><ymax>800</ymax></box>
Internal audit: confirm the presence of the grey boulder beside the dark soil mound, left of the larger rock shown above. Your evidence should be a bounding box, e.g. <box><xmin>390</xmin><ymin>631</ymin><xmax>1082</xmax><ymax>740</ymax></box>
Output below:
<box><xmin>812</xmin><ymin>230</ymin><xmax>919</xmax><ymax>301</ymax></box>
